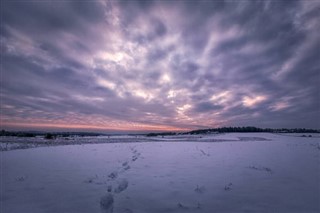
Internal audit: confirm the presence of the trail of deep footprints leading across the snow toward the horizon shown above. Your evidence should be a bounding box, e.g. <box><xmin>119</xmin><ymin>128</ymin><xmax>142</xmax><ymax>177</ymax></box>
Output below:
<box><xmin>99</xmin><ymin>147</ymin><xmax>141</xmax><ymax>213</ymax></box>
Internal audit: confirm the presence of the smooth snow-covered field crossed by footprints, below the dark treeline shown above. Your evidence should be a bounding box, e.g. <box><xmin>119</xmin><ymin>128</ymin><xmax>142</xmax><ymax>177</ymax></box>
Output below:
<box><xmin>0</xmin><ymin>133</ymin><xmax>320</xmax><ymax>213</ymax></box>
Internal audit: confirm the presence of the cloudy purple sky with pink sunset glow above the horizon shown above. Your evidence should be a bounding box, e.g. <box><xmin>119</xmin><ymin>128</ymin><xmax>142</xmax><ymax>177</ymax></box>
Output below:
<box><xmin>0</xmin><ymin>0</ymin><xmax>320</xmax><ymax>131</ymax></box>
